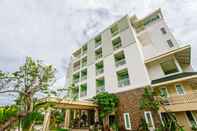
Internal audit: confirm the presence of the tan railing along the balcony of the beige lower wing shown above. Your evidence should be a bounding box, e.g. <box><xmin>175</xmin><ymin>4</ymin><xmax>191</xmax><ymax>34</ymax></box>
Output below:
<box><xmin>164</xmin><ymin>92</ymin><xmax>197</xmax><ymax>105</ymax></box>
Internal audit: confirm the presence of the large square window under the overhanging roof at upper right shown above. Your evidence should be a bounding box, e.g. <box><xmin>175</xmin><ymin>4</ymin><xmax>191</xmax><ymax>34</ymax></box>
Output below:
<box><xmin>160</xmin><ymin>60</ymin><xmax>179</xmax><ymax>75</ymax></box>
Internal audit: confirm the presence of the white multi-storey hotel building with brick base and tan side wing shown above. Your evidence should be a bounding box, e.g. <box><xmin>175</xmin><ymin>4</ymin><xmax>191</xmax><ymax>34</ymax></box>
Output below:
<box><xmin>67</xmin><ymin>9</ymin><xmax>197</xmax><ymax>131</ymax></box>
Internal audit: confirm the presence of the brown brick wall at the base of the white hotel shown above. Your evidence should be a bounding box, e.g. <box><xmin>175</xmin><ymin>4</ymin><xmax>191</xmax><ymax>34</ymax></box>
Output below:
<box><xmin>116</xmin><ymin>88</ymin><xmax>160</xmax><ymax>131</ymax></box>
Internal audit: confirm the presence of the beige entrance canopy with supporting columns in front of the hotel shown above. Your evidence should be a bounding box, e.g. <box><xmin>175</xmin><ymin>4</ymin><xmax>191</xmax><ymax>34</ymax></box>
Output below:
<box><xmin>37</xmin><ymin>97</ymin><xmax>98</xmax><ymax>131</ymax></box>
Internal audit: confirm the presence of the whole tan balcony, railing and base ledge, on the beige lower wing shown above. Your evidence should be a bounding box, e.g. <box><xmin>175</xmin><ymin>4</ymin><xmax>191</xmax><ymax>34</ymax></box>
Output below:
<box><xmin>160</xmin><ymin>92</ymin><xmax>197</xmax><ymax>112</ymax></box>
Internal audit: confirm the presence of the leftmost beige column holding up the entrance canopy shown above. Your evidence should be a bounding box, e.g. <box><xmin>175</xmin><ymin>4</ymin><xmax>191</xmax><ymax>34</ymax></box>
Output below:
<box><xmin>42</xmin><ymin>108</ymin><xmax>51</xmax><ymax>131</ymax></box>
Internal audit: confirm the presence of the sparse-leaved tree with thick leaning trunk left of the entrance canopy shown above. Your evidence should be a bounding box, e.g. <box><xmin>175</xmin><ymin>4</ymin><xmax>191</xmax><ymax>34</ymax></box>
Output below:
<box><xmin>0</xmin><ymin>57</ymin><xmax>55</xmax><ymax>130</ymax></box>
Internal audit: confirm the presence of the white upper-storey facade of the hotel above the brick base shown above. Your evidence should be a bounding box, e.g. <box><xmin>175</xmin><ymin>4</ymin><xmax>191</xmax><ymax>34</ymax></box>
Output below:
<box><xmin>67</xmin><ymin>10</ymin><xmax>192</xmax><ymax>99</ymax></box>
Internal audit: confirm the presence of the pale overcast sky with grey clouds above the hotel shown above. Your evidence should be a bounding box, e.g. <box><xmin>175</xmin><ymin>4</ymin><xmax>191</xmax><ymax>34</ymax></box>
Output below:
<box><xmin>0</xmin><ymin>0</ymin><xmax>197</xmax><ymax>103</ymax></box>
